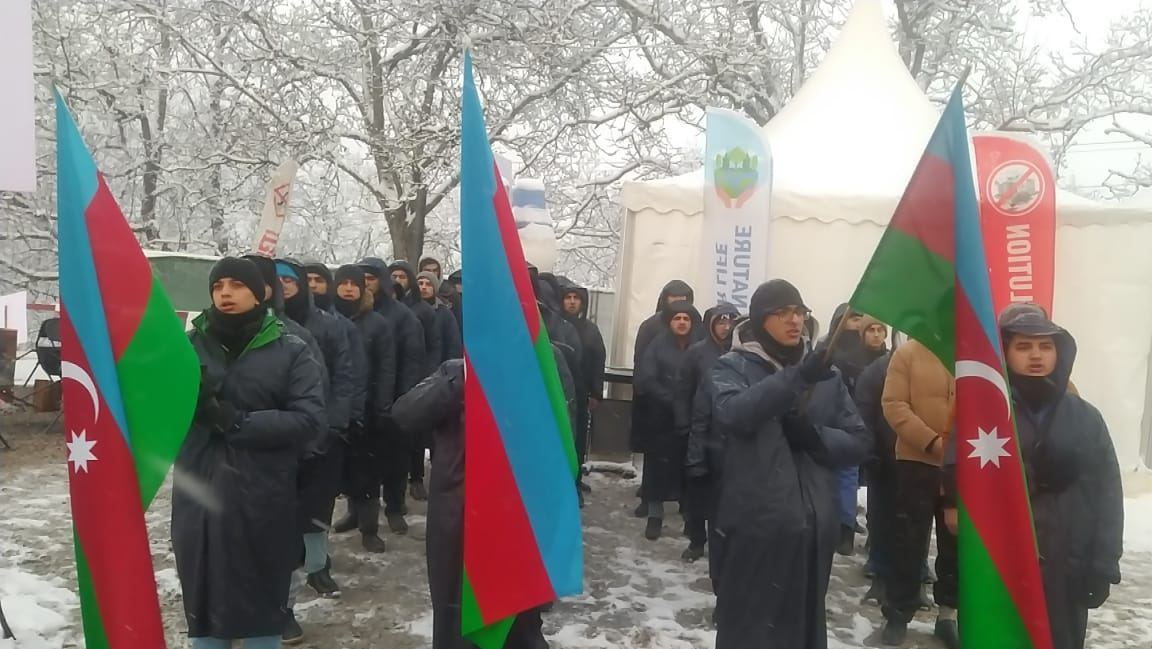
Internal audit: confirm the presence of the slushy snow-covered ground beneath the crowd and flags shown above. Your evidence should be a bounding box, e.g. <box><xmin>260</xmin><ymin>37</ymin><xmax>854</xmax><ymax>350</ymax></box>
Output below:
<box><xmin>0</xmin><ymin>428</ymin><xmax>1152</xmax><ymax>649</ymax></box>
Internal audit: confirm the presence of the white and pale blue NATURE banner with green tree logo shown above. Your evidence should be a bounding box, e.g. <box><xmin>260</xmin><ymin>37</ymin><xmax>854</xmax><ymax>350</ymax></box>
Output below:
<box><xmin>696</xmin><ymin>108</ymin><xmax>772</xmax><ymax>312</ymax></box>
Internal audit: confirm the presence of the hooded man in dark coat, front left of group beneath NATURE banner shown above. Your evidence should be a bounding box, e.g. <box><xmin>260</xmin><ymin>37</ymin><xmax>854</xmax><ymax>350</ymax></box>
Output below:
<box><xmin>632</xmin><ymin>301</ymin><xmax>700</xmax><ymax>541</ymax></box>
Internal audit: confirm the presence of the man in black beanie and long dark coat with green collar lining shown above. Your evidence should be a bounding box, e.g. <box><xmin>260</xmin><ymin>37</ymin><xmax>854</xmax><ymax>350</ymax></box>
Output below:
<box><xmin>172</xmin><ymin>257</ymin><xmax>328</xmax><ymax>649</ymax></box>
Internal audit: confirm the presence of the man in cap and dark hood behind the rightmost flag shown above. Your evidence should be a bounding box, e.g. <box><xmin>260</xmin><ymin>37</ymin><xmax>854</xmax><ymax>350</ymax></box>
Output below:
<box><xmin>945</xmin><ymin>308</ymin><xmax>1124</xmax><ymax>649</ymax></box>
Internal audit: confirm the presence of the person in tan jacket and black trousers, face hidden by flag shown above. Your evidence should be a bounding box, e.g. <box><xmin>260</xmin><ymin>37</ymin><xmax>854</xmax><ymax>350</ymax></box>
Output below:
<box><xmin>881</xmin><ymin>340</ymin><xmax>960</xmax><ymax>648</ymax></box>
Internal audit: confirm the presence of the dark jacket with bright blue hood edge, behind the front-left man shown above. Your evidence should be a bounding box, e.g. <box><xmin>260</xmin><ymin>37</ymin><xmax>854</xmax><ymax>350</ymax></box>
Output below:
<box><xmin>280</xmin><ymin>259</ymin><xmax>355</xmax><ymax>453</ymax></box>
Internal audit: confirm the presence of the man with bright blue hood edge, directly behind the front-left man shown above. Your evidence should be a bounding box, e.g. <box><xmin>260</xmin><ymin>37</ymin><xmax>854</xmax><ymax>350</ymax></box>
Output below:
<box><xmin>276</xmin><ymin>259</ymin><xmax>354</xmax><ymax>622</ymax></box>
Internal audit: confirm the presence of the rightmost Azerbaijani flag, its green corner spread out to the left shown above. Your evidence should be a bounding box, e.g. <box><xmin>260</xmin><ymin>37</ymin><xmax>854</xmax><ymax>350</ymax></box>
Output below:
<box><xmin>850</xmin><ymin>85</ymin><xmax>1052</xmax><ymax>649</ymax></box>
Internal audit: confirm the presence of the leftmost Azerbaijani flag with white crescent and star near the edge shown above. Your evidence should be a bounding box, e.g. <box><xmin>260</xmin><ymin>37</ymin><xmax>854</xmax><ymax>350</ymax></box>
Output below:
<box><xmin>55</xmin><ymin>93</ymin><xmax>199</xmax><ymax>649</ymax></box>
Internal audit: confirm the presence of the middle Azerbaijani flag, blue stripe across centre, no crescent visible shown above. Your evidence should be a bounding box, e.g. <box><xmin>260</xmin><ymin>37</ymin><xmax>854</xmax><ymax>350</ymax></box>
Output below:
<box><xmin>460</xmin><ymin>53</ymin><xmax>584</xmax><ymax>649</ymax></box>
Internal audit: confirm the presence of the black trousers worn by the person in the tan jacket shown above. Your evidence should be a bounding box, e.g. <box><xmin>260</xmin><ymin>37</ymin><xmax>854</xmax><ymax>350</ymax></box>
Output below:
<box><xmin>884</xmin><ymin>460</ymin><xmax>958</xmax><ymax>624</ymax></box>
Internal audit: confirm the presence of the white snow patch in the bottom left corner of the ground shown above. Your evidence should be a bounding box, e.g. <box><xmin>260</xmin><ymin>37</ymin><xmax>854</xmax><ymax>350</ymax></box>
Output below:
<box><xmin>0</xmin><ymin>567</ymin><xmax>79</xmax><ymax>649</ymax></box>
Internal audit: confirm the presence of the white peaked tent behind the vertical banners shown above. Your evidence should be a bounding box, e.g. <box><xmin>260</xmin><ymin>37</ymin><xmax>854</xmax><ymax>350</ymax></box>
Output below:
<box><xmin>612</xmin><ymin>0</ymin><xmax>1152</xmax><ymax>468</ymax></box>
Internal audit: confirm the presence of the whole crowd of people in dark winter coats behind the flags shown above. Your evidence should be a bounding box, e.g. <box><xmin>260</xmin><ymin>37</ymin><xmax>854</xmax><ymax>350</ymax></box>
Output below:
<box><xmin>172</xmin><ymin>255</ymin><xmax>1123</xmax><ymax>649</ymax></box>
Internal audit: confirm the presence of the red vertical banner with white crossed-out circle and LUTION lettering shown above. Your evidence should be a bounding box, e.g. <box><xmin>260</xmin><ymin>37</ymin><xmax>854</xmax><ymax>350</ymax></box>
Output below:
<box><xmin>972</xmin><ymin>134</ymin><xmax>1056</xmax><ymax>314</ymax></box>
